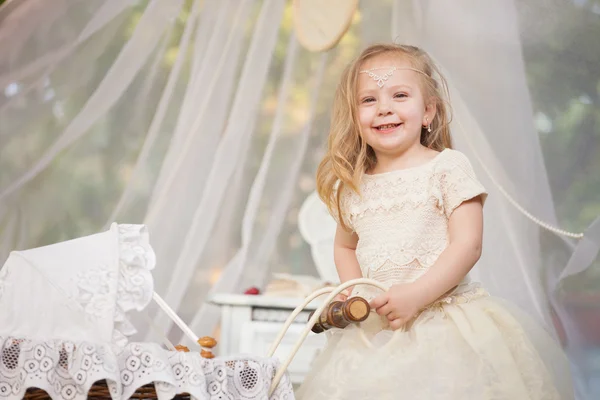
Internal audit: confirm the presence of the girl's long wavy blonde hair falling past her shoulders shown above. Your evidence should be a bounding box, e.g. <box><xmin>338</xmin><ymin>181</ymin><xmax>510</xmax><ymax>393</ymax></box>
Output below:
<box><xmin>317</xmin><ymin>44</ymin><xmax>452</xmax><ymax>230</ymax></box>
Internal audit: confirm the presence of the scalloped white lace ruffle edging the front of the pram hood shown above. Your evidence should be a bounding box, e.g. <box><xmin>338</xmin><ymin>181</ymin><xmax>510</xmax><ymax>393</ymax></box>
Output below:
<box><xmin>113</xmin><ymin>224</ymin><xmax>156</xmax><ymax>347</ymax></box>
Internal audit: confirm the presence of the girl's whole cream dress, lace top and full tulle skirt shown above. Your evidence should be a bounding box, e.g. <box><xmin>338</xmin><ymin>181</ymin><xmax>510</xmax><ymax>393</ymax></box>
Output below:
<box><xmin>296</xmin><ymin>149</ymin><xmax>573</xmax><ymax>400</ymax></box>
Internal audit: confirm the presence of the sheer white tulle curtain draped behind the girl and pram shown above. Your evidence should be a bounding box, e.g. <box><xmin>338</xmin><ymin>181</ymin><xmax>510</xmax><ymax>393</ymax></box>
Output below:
<box><xmin>0</xmin><ymin>0</ymin><xmax>600</xmax><ymax>396</ymax></box>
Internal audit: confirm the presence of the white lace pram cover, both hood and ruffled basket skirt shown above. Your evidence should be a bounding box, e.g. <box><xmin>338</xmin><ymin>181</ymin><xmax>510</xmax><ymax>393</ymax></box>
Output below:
<box><xmin>0</xmin><ymin>224</ymin><xmax>293</xmax><ymax>399</ymax></box>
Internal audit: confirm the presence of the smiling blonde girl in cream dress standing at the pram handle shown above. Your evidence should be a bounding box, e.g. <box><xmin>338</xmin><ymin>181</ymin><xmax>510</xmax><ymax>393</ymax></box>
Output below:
<box><xmin>297</xmin><ymin>45</ymin><xmax>573</xmax><ymax>400</ymax></box>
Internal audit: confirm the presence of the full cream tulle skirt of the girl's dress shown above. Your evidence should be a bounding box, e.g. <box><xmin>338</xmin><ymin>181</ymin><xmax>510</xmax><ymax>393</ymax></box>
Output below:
<box><xmin>295</xmin><ymin>288</ymin><xmax>574</xmax><ymax>400</ymax></box>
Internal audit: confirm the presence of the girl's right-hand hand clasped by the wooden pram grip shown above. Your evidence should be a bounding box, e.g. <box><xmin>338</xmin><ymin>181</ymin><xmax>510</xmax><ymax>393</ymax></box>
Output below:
<box><xmin>371</xmin><ymin>283</ymin><xmax>426</xmax><ymax>330</ymax></box>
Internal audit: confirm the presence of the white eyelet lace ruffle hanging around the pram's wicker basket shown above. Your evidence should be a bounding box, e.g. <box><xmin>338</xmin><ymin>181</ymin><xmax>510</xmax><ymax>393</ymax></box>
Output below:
<box><xmin>0</xmin><ymin>336</ymin><xmax>293</xmax><ymax>400</ymax></box>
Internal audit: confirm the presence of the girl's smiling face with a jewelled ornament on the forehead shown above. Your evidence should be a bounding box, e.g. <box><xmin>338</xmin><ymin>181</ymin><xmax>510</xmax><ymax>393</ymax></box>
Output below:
<box><xmin>357</xmin><ymin>54</ymin><xmax>435</xmax><ymax>158</ymax></box>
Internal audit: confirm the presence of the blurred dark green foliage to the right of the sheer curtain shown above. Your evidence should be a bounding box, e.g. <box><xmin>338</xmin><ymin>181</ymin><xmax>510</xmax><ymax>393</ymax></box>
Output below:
<box><xmin>516</xmin><ymin>0</ymin><xmax>600</xmax><ymax>293</ymax></box>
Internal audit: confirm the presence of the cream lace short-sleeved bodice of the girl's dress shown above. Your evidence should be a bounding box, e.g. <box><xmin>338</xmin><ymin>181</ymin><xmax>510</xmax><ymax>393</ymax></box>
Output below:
<box><xmin>341</xmin><ymin>149</ymin><xmax>487</xmax><ymax>294</ymax></box>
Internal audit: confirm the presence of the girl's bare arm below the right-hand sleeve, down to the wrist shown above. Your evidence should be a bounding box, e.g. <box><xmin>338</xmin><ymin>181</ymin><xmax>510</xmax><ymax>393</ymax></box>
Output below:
<box><xmin>414</xmin><ymin>196</ymin><xmax>483</xmax><ymax>307</ymax></box>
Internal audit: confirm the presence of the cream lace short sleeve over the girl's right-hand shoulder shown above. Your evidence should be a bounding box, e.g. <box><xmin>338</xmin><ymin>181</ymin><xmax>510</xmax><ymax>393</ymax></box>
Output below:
<box><xmin>438</xmin><ymin>150</ymin><xmax>487</xmax><ymax>217</ymax></box>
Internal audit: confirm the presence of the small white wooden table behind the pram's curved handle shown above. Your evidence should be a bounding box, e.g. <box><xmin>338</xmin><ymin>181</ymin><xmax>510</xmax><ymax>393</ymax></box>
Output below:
<box><xmin>209</xmin><ymin>294</ymin><xmax>325</xmax><ymax>384</ymax></box>
